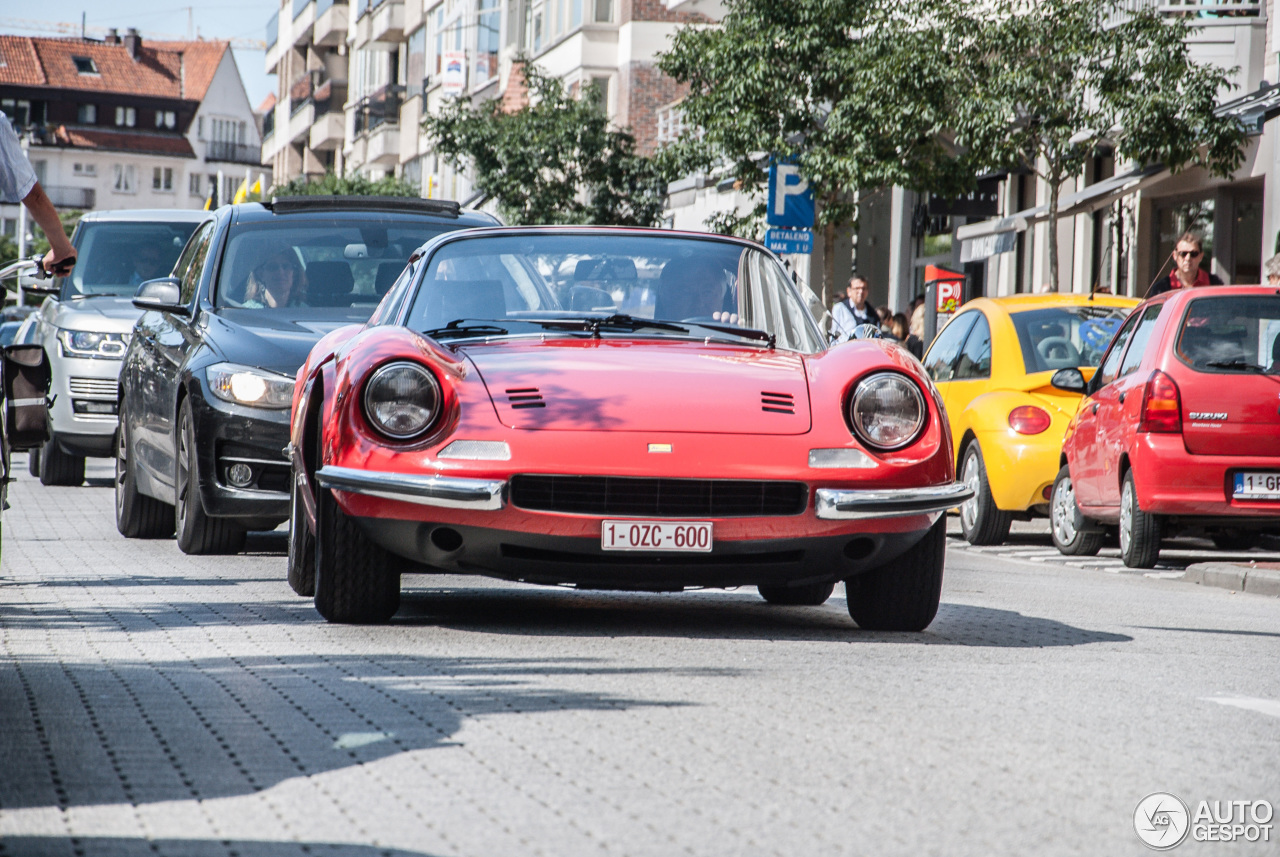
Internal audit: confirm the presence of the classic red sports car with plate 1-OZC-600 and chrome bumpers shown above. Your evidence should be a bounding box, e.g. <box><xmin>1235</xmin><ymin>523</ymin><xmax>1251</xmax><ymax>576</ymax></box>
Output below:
<box><xmin>289</xmin><ymin>228</ymin><xmax>969</xmax><ymax>631</ymax></box>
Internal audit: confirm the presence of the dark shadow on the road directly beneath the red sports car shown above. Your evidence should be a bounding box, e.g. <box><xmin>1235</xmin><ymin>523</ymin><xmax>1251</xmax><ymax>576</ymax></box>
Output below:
<box><xmin>393</xmin><ymin>587</ymin><xmax>1133</xmax><ymax>647</ymax></box>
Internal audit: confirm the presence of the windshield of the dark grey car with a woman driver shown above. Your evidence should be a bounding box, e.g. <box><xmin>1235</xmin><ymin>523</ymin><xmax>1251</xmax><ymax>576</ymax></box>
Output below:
<box><xmin>214</xmin><ymin>214</ymin><xmax>457</xmax><ymax>320</ymax></box>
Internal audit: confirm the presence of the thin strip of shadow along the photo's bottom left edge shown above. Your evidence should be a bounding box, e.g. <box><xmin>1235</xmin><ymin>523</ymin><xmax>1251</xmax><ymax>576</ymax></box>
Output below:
<box><xmin>0</xmin><ymin>837</ymin><xmax>430</xmax><ymax>857</ymax></box>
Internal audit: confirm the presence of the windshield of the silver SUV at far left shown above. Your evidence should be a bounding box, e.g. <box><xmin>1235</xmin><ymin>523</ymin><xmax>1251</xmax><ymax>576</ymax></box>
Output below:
<box><xmin>59</xmin><ymin>221</ymin><xmax>200</xmax><ymax>301</ymax></box>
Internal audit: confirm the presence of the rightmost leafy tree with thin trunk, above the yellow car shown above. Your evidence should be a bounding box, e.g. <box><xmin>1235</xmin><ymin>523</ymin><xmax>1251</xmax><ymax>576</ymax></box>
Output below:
<box><xmin>952</xmin><ymin>0</ymin><xmax>1244</xmax><ymax>288</ymax></box>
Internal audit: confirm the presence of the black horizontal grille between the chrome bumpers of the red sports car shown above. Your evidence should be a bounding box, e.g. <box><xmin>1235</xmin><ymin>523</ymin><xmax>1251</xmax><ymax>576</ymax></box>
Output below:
<box><xmin>511</xmin><ymin>473</ymin><xmax>809</xmax><ymax>518</ymax></box>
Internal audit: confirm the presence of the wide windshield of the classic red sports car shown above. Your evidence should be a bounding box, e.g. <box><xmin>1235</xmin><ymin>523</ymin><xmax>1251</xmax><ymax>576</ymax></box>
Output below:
<box><xmin>406</xmin><ymin>233</ymin><xmax>824</xmax><ymax>353</ymax></box>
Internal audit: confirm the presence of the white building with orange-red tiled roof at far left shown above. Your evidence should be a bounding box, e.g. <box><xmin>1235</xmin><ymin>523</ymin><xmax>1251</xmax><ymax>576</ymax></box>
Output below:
<box><xmin>0</xmin><ymin>28</ymin><xmax>270</xmax><ymax>245</ymax></box>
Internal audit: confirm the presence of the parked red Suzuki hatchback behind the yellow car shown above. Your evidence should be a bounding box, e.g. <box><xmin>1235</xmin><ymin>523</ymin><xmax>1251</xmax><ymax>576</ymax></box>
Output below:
<box><xmin>1050</xmin><ymin>285</ymin><xmax>1280</xmax><ymax>568</ymax></box>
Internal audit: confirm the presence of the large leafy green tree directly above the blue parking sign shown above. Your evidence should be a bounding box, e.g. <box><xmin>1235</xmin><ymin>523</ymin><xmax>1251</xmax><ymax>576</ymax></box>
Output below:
<box><xmin>658</xmin><ymin>0</ymin><xmax>980</xmax><ymax>306</ymax></box>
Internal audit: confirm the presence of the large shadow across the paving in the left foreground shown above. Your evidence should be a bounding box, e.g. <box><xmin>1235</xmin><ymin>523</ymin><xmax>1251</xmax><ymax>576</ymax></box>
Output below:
<box><xmin>0</xmin><ymin>654</ymin><xmax>701</xmax><ymax>813</ymax></box>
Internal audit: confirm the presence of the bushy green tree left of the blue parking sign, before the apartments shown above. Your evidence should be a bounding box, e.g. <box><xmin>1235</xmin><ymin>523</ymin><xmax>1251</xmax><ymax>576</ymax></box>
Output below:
<box><xmin>422</xmin><ymin>63</ymin><xmax>672</xmax><ymax>226</ymax></box>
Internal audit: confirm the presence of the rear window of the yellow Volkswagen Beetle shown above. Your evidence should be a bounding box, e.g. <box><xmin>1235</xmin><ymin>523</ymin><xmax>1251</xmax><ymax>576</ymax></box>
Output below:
<box><xmin>1011</xmin><ymin>304</ymin><xmax>1130</xmax><ymax>375</ymax></box>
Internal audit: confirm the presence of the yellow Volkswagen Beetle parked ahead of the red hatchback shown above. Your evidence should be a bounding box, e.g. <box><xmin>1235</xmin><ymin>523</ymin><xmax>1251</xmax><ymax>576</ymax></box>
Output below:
<box><xmin>924</xmin><ymin>294</ymin><xmax>1138</xmax><ymax>545</ymax></box>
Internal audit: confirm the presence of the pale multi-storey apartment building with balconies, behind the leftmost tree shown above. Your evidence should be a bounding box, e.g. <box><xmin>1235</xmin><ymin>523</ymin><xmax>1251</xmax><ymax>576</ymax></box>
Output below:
<box><xmin>264</xmin><ymin>0</ymin><xmax>718</xmax><ymax>201</ymax></box>
